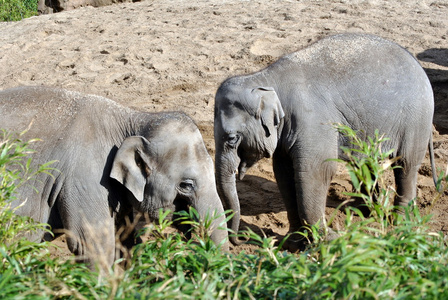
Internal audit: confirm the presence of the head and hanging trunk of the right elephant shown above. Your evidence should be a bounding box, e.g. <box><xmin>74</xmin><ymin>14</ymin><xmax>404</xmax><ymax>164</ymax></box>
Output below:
<box><xmin>214</xmin><ymin>82</ymin><xmax>285</xmax><ymax>244</ymax></box>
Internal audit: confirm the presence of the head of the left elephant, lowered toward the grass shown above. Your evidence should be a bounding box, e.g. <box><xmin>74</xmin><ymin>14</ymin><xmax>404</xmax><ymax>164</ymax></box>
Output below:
<box><xmin>110</xmin><ymin>114</ymin><xmax>228</xmax><ymax>250</ymax></box>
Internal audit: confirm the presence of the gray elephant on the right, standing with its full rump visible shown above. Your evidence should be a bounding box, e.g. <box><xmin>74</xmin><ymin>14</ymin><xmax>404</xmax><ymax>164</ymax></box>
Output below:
<box><xmin>214</xmin><ymin>34</ymin><xmax>434</xmax><ymax>248</ymax></box>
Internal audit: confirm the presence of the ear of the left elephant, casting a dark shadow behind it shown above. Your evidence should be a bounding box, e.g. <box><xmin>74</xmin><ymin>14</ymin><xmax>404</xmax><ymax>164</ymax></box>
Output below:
<box><xmin>110</xmin><ymin>136</ymin><xmax>151</xmax><ymax>202</ymax></box>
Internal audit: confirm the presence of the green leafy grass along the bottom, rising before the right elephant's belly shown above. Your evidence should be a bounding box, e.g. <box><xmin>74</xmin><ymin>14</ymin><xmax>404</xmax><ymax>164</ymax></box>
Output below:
<box><xmin>0</xmin><ymin>127</ymin><xmax>448</xmax><ymax>299</ymax></box>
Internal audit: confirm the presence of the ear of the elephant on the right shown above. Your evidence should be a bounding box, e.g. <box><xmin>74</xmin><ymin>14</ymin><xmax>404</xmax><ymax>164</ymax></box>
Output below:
<box><xmin>252</xmin><ymin>87</ymin><xmax>285</xmax><ymax>137</ymax></box>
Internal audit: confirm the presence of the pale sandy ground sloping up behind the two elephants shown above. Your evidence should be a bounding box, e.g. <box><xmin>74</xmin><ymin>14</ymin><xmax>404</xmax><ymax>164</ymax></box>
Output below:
<box><xmin>0</xmin><ymin>0</ymin><xmax>448</xmax><ymax>258</ymax></box>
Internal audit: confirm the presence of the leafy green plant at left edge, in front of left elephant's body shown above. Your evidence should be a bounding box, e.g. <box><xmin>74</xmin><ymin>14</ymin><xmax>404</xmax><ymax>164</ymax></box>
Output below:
<box><xmin>0</xmin><ymin>130</ymin><xmax>59</xmax><ymax>298</ymax></box>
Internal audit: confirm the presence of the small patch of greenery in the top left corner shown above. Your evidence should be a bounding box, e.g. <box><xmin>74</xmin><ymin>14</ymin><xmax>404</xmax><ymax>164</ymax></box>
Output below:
<box><xmin>0</xmin><ymin>0</ymin><xmax>39</xmax><ymax>22</ymax></box>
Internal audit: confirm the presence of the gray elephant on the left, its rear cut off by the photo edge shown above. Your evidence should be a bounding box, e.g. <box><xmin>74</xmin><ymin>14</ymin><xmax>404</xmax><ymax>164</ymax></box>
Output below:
<box><xmin>0</xmin><ymin>87</ymin><xmax>228</xmax><ymax>267</ymax></box>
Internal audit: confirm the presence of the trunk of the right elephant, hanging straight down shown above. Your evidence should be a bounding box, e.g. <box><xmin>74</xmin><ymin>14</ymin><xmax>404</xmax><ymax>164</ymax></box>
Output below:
<box><xmin>215</xmin><ymin>151</ymin><xmax>243</xmax><ymax>245</ymax></box>
